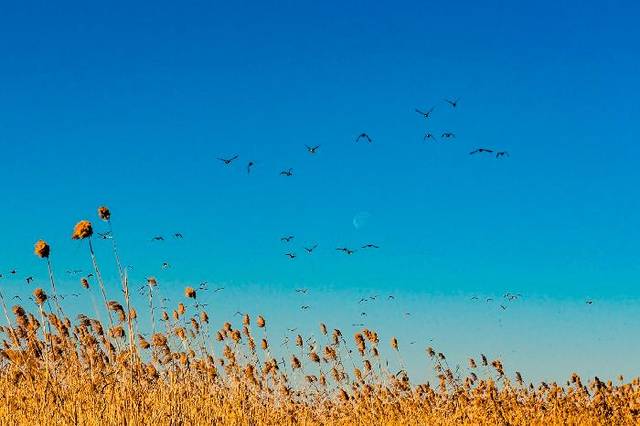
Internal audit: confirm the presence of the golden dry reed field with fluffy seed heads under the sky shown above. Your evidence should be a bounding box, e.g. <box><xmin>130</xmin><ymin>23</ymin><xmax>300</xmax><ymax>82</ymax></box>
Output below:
<box><xmin>0</xmin><ymin>207</ymin><xmax>640</xmax><ymax>425</ymax></box>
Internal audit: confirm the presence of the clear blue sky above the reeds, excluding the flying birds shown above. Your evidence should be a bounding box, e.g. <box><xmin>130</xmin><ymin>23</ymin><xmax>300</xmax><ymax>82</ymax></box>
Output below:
<box><xmin>0</xmin><ymin>1</ymin><xmax>640</xmax><ymax>379</ymax></box>
